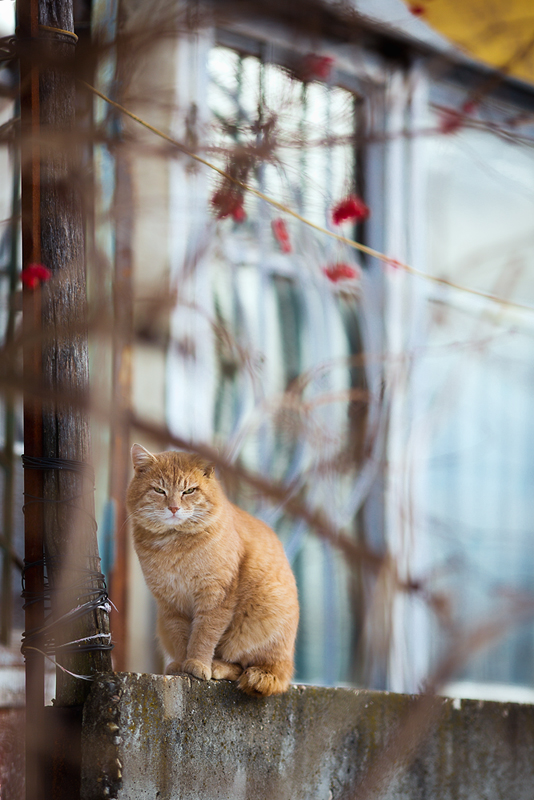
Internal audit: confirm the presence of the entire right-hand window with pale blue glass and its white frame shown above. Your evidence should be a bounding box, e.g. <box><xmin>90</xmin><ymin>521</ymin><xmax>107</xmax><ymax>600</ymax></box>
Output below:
<box><xmin>389</xmin><ymin>69</ymin><xmax>534</xmax><ymax>697</ymax></box>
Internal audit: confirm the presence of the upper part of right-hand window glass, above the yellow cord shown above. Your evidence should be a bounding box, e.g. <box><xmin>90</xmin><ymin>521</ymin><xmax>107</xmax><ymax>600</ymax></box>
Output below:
<box><xmin>426</xmin><ymin>116</ymin><xmax>534</xmax><ymax>304</ymax></box>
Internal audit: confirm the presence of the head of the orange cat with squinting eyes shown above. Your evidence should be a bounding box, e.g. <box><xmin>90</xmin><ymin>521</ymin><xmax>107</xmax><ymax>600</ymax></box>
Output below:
<box><xmin>128</xmin><ymin>444</ymin><xmax>215</xmax><ymax>537</ymax></box>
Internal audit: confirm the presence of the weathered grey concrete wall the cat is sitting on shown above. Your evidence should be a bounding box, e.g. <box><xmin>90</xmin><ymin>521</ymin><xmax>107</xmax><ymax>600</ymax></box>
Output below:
<box><xmin>82</xmin><ymin>673</ymin><xmax>534</xmax><ymax>800</ymax></box>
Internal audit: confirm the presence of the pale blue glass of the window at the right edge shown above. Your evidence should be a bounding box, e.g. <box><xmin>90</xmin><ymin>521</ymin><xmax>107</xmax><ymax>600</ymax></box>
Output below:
<box><xmin>414</xmin><ymin>98</ymin><xmax>534</xmax><ymax>685</ymax></box>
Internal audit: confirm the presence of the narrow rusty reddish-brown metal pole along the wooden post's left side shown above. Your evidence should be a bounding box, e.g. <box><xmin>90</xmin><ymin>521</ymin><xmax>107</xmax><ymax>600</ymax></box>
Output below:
<box><xmin>17</xmin><ymin>0</ymin><xmax>44</xmax><ymax>800</ymax></box>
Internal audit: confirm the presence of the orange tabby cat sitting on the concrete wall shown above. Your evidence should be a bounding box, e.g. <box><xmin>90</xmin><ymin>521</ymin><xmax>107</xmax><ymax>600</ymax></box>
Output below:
<box><xmin>127</xmin><ymin>444</ymin><xmax>299</xmax><ymax>695</ymax></box>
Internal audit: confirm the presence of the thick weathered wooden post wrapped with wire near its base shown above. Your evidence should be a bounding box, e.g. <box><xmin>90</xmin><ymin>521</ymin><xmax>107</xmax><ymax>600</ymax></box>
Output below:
<box><xmin>39</xmin><ymin>0</ymin><xmax>111</xmax><ymax>707</ymax></box>
